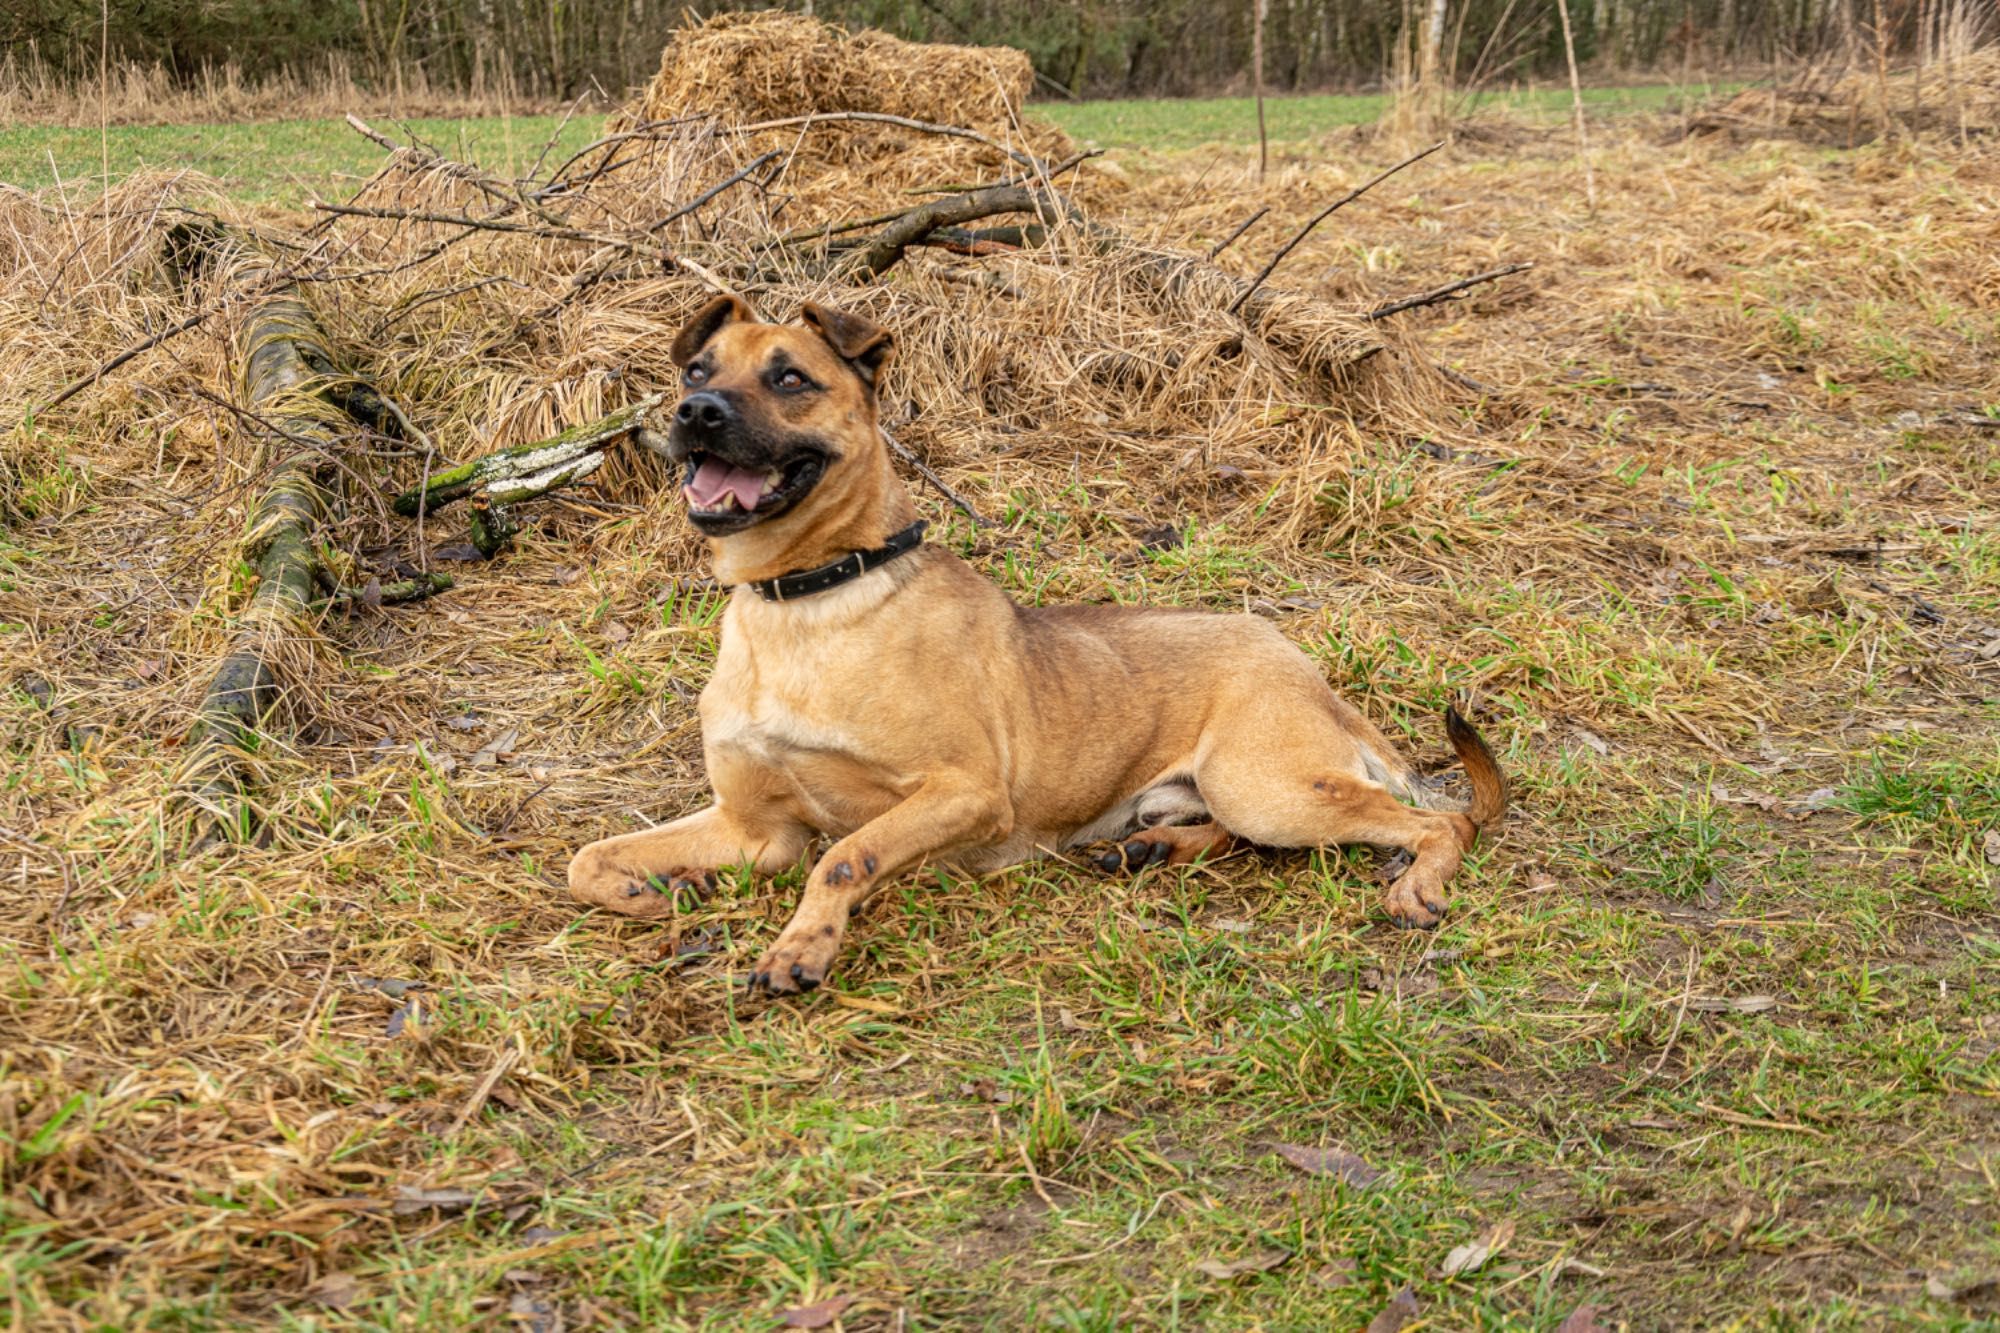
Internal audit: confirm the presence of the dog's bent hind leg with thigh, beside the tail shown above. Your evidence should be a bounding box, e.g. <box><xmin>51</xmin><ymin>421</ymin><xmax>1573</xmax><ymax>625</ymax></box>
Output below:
<box><xmin>1194</xmin><ymin>713</ymin><xmax>1478</xmax><ymax>929</ymax></box>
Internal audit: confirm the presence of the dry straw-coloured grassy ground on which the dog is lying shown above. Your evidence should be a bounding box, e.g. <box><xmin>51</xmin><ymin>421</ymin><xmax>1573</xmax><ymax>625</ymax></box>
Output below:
<box><xmin>0</xmin><ymin>28</ymin><xmax>2000</xmax><ymax>1333</ymax></box>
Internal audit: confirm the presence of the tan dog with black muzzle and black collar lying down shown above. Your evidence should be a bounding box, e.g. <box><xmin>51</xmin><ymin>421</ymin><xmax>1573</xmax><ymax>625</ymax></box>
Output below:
<box><xmin>570</xmin><ymin>296</ymin><xmax>1506</xmax><ymax>993</ymax></box>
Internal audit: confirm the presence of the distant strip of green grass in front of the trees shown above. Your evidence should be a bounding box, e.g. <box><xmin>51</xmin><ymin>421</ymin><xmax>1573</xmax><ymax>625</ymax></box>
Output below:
<box><xmin>0</xmin><ymin>84</ymin><xmax>1736</xmax><ymax>204</ymax></box>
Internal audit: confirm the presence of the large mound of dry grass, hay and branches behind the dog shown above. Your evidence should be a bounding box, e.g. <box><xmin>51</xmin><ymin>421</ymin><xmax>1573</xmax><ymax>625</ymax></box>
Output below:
<box><xmin>0</xmin><ymin>7</ymin><xmax>1472</xmax><ymax>820</ymax></box>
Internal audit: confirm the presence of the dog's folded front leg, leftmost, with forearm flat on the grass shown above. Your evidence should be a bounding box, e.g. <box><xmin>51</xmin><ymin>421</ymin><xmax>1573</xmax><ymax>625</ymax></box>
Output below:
<box><xmin>570</xmin><ymin>805</ymin><xmax>810</xmax><ymax>919</ymax></box>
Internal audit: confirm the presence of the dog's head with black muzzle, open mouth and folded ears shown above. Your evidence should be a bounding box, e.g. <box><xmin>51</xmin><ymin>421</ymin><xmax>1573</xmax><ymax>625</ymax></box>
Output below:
<box><xmin>666</xmin><ymin>296</ymin><xmax>890</xmax><ymax>536</ymax></box>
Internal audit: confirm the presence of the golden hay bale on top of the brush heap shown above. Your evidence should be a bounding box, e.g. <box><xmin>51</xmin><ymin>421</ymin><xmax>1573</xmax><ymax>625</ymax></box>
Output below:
<box><xmin>636</xmin><ymin>10</ymin><xmax>1034</xmax><ymax>128</ymax></box>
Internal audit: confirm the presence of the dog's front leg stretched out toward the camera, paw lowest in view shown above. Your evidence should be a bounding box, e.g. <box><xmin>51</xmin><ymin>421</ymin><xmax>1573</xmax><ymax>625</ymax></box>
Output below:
<box><xmin>750</xmin><ymin>779</ymin><xmax>1014</xmax><ymax>995</ymax></box>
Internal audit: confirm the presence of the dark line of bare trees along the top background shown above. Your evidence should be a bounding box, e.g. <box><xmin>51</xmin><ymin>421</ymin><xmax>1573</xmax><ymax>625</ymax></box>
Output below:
<box><xmin>0</xmin><ymin>0</ymin><xmax>1990</xmax><ymax>98</ymax></box>
